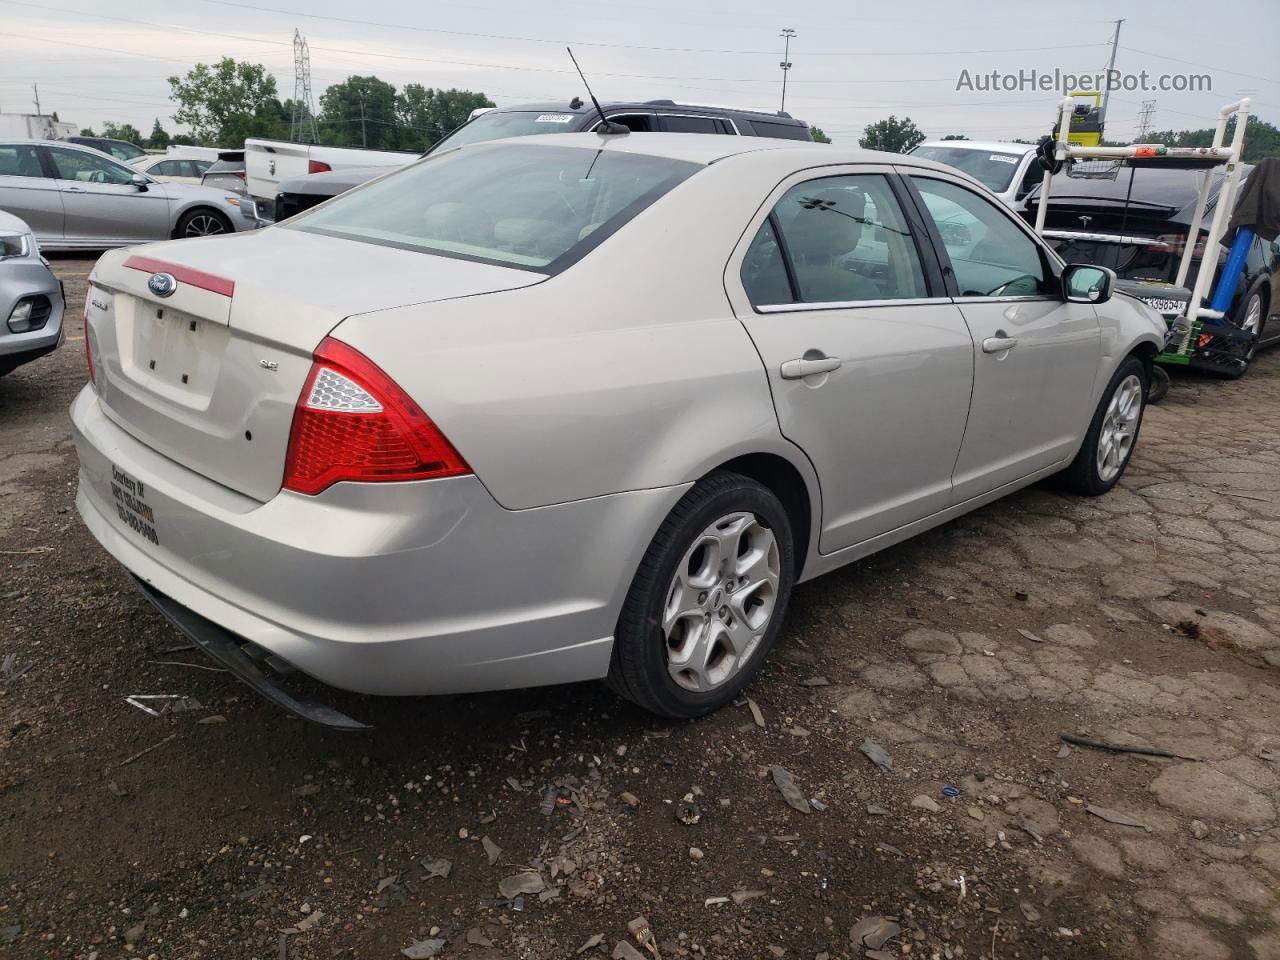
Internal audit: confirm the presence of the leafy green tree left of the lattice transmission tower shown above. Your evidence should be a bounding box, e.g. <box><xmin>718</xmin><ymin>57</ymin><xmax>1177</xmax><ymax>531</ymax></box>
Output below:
<box><xmin>169</xmin><ymin>56</ymin><xmax>282</xmax><ymax>150</ymax></box>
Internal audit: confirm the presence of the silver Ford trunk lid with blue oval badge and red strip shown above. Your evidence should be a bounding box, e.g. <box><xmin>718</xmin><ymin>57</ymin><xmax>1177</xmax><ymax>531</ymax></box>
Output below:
<box><xmin>86</xmin><ymin>229</ymin><xmax>545</xmax><ymax>500</ymax></box>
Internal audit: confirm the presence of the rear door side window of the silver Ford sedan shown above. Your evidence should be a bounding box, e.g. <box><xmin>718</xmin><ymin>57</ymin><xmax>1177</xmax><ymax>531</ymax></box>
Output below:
<box><xmin>742</xmin><ymin>174</ymin><xmax>928</xmax><ymax>306</ymax></box>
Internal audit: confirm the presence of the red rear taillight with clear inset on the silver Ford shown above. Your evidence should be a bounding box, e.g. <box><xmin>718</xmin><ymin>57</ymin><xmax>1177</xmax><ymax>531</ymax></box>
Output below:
<box><xmin>284</xmin><ymin>337</ymin><xmax>471</xmax><ymax>494</ymax></box>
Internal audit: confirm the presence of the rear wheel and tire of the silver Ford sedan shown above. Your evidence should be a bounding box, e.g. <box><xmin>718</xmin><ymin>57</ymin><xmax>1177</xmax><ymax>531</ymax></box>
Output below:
<box><xmin>607</xmin><ymin>471</ymin><xmax>795</xmax><ymax>719</ymax></box>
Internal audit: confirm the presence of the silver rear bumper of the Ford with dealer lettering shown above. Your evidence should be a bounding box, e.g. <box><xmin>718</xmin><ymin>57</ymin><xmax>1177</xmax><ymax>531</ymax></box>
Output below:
<box><xmin>72</xmin><ymin>387</ymin><xmax>687</xmax><ymax>694</ymax></box>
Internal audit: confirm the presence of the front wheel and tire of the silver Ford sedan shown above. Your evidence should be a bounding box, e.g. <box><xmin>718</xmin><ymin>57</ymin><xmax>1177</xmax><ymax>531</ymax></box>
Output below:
<box><xmin>1062</xmin><ymin>356</ymin><xmax>1147</xmax><ymax>497</ymax></box>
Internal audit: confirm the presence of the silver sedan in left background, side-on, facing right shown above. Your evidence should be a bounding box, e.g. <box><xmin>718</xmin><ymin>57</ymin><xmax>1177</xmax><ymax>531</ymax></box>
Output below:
<box><xmin>0</xmin><ymin>140</ymin><xmax>255</xmax><ymax>250</ymax></box>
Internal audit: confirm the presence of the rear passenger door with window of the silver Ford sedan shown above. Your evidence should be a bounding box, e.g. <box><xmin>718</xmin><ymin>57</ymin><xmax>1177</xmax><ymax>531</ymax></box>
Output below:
<box><xmin>726</xmin><ymin>166</ymin><xmax>973</xmax><ymax>553</ymax></box>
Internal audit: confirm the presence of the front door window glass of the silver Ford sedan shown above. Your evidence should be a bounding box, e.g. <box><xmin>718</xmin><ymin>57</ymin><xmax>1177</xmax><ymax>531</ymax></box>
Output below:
<box><xmin>911</xmin><ymin>177</ymin><xmax>1050</xmax><ymax>297</ymax></box>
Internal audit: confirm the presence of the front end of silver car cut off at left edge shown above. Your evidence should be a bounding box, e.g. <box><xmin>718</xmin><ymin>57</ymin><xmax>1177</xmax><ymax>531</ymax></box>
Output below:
<box><xmin>0</xmin><ymin>211</ymin><xmax>63</xmax><ymax>376</ymax></box>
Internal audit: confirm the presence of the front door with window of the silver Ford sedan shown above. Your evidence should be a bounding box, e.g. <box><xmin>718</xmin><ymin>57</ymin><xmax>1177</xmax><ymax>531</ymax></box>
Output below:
<box><xmin>909</xmin><ymin>173</ymin><xmax>1102</xmax><ymax>503</ymax></box>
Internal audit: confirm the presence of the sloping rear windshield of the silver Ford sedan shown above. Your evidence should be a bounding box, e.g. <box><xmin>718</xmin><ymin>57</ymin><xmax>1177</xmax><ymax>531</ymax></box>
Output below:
<box><xmin>293</xmin><ymin>143</ymin><xmax>700</xmax><ymax>273</ymax></box>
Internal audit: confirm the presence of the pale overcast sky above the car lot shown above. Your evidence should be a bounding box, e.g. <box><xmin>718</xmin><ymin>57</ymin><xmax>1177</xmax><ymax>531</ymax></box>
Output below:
<box><xmin>0</xmin><ymin>0</ymin><xmax>1280</xmax><ymax>142</ymax></box>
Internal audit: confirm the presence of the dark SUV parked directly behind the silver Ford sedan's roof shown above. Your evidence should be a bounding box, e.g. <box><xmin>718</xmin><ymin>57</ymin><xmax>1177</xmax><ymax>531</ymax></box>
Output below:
<box><xmin>259</xmin><ymin>97</ymin><xmax>813</xmax><ymax>220</ymax></box>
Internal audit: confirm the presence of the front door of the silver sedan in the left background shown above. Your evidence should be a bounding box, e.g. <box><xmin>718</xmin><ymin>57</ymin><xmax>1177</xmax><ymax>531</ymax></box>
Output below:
<box><xmin>45</xmin><ymin>146</ymin><xmax>172</xmax><ymax>243</ymax></box>
